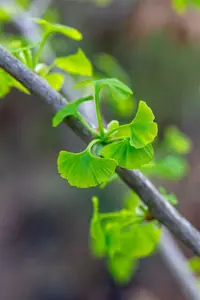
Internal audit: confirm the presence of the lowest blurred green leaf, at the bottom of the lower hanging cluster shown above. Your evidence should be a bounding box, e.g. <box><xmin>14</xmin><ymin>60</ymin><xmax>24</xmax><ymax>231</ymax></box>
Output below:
<box><xmin>108</xmin><ymin>254</ymin><xmax>137</xmax><ymax>284</ymax></box>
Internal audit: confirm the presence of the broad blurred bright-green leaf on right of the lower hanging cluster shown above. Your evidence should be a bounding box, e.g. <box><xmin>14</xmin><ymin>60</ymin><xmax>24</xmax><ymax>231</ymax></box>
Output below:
<box><xmin>121</xmin><ymin>222</ymin><xmax>161</xmax><ymax>259</ymax></box>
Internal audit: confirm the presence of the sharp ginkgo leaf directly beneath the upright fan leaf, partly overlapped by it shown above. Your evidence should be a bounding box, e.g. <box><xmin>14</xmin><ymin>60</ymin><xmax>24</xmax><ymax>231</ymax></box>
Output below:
<box><xmin>101</xmin><ymin>139</ymin><xmax>153</xmax><ymax>170</ymax></box>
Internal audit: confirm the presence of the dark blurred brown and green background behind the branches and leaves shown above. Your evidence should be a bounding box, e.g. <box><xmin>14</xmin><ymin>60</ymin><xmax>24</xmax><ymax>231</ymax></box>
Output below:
<box><xmin>0</xmin><ymin>0</ymin><xmax>200</xmax><ymax>300</ymax></box>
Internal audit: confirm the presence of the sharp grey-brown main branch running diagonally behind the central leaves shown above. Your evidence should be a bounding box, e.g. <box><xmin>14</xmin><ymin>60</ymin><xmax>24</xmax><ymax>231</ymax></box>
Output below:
<box><xmin>0</xmin><ymin>46</ymin><xmax>200</xmax><ymax>255</ymax></box>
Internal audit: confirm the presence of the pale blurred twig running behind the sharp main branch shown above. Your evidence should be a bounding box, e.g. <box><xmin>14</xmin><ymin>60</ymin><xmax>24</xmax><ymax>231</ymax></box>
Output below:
<box><xmin>2</xmin><ymin>0</ymin><xmax>199</xmax><ymax>300</ymax></box>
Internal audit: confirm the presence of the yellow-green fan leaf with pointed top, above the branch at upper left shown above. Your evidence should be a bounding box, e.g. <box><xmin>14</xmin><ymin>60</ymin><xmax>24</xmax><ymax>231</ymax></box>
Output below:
<box><xmin>55</xmin><ymin>49</ymin><xmax>92</xmax><ymax>76</ymax></box>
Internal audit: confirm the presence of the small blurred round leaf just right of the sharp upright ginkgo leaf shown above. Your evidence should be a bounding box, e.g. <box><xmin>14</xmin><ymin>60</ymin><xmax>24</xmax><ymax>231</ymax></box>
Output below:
<box><xmin>164</xmin><ymin>126</ymin><xmax>192</xmax><ymax>154</ymax></box>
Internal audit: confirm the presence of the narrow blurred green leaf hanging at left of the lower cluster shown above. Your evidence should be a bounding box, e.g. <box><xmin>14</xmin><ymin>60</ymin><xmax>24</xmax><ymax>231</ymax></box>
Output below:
<box><xmin>90</xmin><ymin>197</ymin><xmax>107</xmax><ymax>257</ymax></box>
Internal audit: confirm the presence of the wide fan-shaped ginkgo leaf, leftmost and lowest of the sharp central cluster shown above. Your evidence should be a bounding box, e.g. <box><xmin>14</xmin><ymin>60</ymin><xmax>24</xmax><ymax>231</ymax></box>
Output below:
<box><xmin>57</xmin><ymin>149</ymin><xmax>117</xmax><ymax>188</ymax></box>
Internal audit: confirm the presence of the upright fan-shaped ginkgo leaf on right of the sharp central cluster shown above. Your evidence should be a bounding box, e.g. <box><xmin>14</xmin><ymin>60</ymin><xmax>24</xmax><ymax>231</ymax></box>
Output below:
<box><xmin>129</xmin><ymin>101</ymin><xmax>158</xmax><ymax>148</ymax></box>
